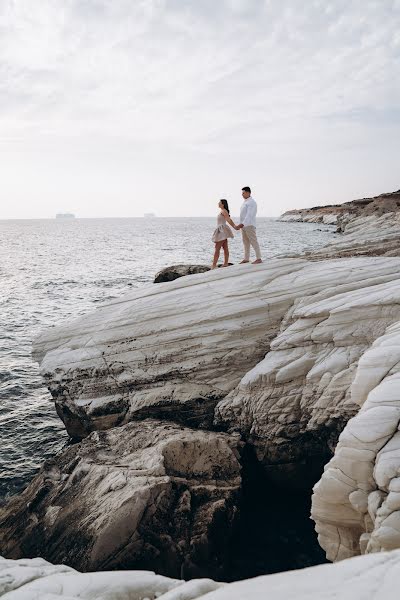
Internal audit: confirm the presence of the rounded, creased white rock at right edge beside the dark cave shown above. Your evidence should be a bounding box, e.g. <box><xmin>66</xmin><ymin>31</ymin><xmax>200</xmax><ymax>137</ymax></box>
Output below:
<box><xmin>312</xmin><ymin>321</ymin><xmax>400</xmax><ymax>560</ymax></box>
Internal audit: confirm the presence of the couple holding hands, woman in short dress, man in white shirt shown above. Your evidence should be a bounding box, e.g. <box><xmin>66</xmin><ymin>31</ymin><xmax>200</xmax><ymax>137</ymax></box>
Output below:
<box><xmin>211</xmin><ymin>186</ymin><xmax>262</xmax><ymax>269</ymax></box>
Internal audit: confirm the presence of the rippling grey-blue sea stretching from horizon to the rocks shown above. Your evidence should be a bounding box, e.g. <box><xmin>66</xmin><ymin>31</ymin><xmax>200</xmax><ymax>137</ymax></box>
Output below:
<box><xmin>0</xmin><ymin>218</ymin><xmax>335</xmax><ymax>502</ymax></box>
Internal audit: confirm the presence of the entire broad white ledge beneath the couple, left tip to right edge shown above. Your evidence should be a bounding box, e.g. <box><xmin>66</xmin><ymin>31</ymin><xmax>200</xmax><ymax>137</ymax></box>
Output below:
<box><xmin>35</xmin><ymin>258</ymin><xmax>400</xmax><ymax>446</ymax></box>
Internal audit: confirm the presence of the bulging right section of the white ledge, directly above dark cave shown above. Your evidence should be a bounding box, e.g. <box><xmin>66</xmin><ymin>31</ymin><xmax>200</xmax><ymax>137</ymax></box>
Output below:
<box><xmin>216</xmin><ymin>258</ymin><xmax>400</xmax><ymax>485</ymax></box>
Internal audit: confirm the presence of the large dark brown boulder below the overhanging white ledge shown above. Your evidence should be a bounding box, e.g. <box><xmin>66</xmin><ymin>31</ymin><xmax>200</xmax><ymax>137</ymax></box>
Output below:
<box><xmin>0</xmin><ymin>420</ymin><xmax>241</xmax><ymax>579</ymax></box>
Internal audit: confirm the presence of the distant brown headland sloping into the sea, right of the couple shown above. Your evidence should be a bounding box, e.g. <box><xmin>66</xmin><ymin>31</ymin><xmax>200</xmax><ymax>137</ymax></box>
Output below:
<box><xmin>279</xmin><ymin>190</ymin><xmax>400</xmax><ymax>226</ymax></box>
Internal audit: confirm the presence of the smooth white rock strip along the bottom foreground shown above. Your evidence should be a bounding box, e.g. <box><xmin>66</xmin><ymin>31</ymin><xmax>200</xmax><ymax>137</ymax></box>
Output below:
<box><xmin>0</xmin><ymin>551</ymin><xmax>400</xmax><ymax>600</ymax></box>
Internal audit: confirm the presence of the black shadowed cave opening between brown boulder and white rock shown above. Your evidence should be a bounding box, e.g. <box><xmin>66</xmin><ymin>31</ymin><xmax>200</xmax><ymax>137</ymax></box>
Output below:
<box><xmin>227</xmin><ymin>445</ymin><xmax>328</xmax><ymax>581</ymax></box>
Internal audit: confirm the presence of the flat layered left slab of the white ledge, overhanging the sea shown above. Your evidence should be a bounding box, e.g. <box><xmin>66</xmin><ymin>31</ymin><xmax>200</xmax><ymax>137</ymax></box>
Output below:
<box><xmin>34</xmin><ymin>259</ymin><xmax>306</xmax><ymax>438</ymax></box>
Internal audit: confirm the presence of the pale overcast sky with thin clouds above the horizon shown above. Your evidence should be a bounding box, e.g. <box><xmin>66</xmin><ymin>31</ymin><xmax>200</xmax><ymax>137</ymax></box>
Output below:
<box><xmin>0</xmin><ymin>0</ymin><xmax>400</xmax><ymax>219</ymax></box>
